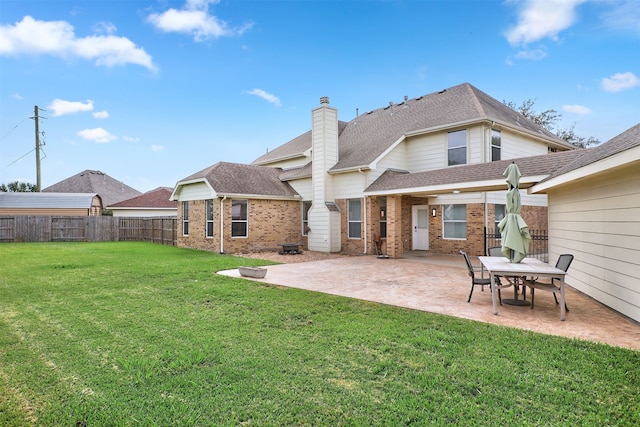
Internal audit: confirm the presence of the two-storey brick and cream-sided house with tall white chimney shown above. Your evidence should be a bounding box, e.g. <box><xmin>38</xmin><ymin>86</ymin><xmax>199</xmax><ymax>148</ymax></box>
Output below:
<box><xmin>172</xmin><ymin>83</ymin><xmax>575</xmax><ymax>257</ymax></box>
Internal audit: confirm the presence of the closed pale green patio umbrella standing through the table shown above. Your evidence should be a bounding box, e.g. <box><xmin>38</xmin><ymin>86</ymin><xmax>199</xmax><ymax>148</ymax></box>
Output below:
<box><xmin>498</xmin><ymin>163</ymin><xmax>531</xmax><ymax>262</ymax></box>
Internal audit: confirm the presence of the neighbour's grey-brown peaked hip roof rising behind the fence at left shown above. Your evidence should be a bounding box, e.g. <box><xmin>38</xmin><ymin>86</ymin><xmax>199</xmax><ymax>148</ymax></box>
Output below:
<box><xmin>42</xmin><ymin>170</ymin><xmax>142</xmax><ymax>206</ymax></box>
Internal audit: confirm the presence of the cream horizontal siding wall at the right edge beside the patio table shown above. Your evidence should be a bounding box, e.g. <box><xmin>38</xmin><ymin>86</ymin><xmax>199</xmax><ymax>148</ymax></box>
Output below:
<box><xmin>549</xmin><ymin>165</ymin><xmax>640</xmax><ymax>321</ymax></box>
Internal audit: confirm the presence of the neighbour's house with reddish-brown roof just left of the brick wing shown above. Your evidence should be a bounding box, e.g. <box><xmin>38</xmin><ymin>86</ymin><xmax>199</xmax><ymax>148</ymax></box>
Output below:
<box><xmin>107</xmin><ymin>187</ymin><xmax>178</xmax><ymax>217</ymax></box>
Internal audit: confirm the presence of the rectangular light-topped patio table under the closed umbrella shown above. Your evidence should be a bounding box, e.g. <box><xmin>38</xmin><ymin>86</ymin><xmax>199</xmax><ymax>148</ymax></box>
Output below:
<box><xmin>478</xmin><ymin>256</ymin><xmax>567</xmax><ymax>320</ymax></box>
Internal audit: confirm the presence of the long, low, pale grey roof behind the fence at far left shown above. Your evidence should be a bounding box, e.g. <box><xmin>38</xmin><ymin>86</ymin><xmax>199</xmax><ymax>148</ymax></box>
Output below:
<box><xmin>0</xmin><ymin>192</ymin><xmax>100</xmax><ymax>209</ymax></box>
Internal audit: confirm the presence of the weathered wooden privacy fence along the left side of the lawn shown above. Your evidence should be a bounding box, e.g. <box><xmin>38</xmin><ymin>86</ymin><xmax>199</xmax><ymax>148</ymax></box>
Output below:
<box><xmin>0</xmin><ymin>215</ymin><xmax>177</xmax><ymax>246</ymax></box>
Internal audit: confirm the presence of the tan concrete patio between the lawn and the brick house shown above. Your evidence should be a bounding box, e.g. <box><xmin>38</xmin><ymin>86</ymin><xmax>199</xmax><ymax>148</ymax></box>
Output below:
<box><xmin>219</xmin><ymin>252</ymin><xmax>640</xmax><ymax>351</ymax></box>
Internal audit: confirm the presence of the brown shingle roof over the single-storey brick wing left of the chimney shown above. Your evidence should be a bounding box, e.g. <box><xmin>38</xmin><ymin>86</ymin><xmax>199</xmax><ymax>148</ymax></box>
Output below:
<box><xmin>172</xmin><ymin>162</ymin><xmax>298</xmax><ymax>200</ymax></box>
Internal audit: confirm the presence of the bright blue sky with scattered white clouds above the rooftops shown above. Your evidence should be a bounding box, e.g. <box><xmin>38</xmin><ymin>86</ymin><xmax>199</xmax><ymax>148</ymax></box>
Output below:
<box><xmin>0</xmin><ymin>0</ymin><xmax>640</xmax><ymax>191</ymax></box>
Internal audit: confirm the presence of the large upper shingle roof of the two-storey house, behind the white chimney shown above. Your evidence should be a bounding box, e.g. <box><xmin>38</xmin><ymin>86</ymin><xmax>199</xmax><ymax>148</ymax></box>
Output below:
<box><xmin>253</xmin><ymin>83</ymin><xmax>574</xmax><ymax>171</ymax></box>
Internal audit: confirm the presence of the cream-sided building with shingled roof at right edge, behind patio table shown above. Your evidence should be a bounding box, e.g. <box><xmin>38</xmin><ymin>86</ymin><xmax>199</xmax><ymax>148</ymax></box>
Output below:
<box><xmin>529</xmin><ymin>124</ymin><xmax>640</xmax><ymax>322</ymax></box>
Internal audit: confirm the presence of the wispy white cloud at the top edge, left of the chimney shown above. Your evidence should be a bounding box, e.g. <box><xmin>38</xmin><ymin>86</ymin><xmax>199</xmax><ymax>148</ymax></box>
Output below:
<box><xmin>147</xmin><ymin>0</ymin><xmax>253</xmax><ymax>42</ymax></box>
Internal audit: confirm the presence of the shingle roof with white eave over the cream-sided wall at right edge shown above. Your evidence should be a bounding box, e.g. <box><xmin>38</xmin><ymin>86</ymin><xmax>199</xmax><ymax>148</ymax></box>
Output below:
<box><xmin>533</xmin><ymin>123</ymin><xmax>640</xmax><ymax>192</ymax></box>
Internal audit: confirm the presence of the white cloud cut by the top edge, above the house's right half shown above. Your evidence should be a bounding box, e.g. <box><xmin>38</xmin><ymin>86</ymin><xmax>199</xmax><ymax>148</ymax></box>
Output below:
<box><xmin>505</xmin><ymin>0</ymin><xmax>586</xmax><ymax>46</ymax></box>
